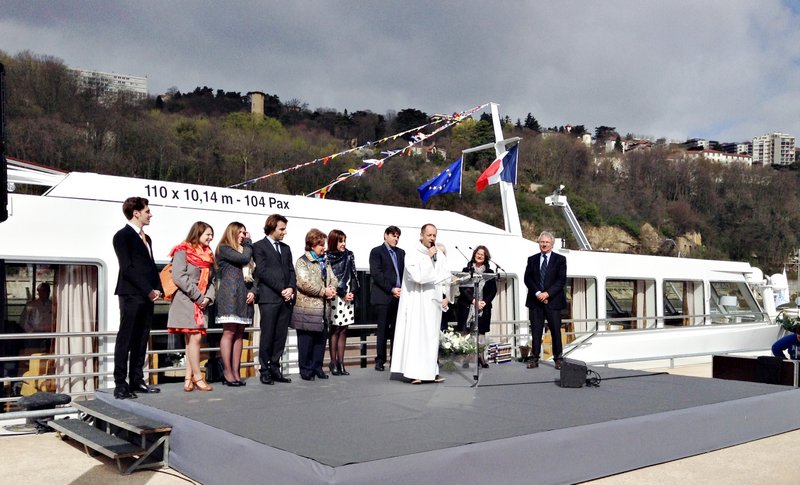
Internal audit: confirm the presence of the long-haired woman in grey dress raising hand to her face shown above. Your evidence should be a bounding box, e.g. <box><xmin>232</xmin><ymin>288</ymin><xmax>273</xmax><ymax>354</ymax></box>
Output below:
<box><xmin>214</xmin><ymin>222</ymin><xmax>256</xmax><ymax>387</ymax></box>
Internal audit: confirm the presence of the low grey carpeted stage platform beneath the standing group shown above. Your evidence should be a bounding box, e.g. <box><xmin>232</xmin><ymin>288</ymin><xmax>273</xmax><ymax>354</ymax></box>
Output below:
<box><xmin>96</xmin><ymin>363</ymin><xmax>800</xmax><ymax>485</ymax></box>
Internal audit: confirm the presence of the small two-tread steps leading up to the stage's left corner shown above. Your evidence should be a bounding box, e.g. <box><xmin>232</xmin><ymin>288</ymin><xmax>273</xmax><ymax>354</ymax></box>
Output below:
<box><xmin>48</xmin><ymin>399</ymin><xmax>172</xmax><ymax>475</ymax></box>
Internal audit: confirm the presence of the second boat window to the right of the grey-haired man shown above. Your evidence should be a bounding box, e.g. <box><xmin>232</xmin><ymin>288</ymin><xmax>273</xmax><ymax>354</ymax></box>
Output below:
<box><xmin>606</xmin><ymin>279</ymin><xmax>656</xmax><ymax>330</ymax></box>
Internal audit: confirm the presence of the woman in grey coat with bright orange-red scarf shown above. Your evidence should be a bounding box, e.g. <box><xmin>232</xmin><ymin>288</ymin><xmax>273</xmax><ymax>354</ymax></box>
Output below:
<box><xmin>167</xmin><ymin>221</ymin><xmax>216</xmax><ymax>392</ymax></box>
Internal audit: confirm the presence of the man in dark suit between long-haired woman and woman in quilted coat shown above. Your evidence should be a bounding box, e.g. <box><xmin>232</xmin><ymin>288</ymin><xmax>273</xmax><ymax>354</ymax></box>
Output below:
<box><xmin>253</xmin><ymin>214</ymin><xmax>297</xmax><ymax>385</ymax></box>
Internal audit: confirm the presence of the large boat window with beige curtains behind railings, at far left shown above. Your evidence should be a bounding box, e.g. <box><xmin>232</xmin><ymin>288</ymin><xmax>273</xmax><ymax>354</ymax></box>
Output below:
<box><xmin>0</xmin><ymin>261</ymin><xmax>98</xmax><ymax>396</ymax></box>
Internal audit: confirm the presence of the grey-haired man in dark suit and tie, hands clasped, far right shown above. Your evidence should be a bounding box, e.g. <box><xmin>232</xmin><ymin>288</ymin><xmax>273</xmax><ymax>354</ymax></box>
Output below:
<box><xmin>525</xmin><ymin>231</ymin><xmax>567</xmax><ymax>369</ymax></box>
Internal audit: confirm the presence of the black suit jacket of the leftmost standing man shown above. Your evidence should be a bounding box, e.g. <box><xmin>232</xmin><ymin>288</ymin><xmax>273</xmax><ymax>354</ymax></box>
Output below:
<box><xmin>113</xmin><ymin>224</ymin><xmax>164</xmax><ymax>298</ymax></box>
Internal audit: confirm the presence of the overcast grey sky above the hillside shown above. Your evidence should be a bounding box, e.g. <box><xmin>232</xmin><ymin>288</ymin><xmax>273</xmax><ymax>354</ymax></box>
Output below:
<box><xmin>0</xmin><ymin>0</ymin><xmax>800</xmax><ymax>141</ymax></box>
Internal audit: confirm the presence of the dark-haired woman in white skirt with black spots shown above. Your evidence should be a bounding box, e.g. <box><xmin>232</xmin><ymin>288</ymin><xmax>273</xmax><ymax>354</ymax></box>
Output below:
<box><xmin>325</xmin><ymin>229</ymin><xmax>359</xmax><ymax>376</ymax></box>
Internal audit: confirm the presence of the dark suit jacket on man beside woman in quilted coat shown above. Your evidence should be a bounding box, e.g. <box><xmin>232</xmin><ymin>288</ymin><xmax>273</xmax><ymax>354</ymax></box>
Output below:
<box><xmin>253</xmin><ymin>237</ymin><xmax>297</xmax><ymax>303</ymax></box>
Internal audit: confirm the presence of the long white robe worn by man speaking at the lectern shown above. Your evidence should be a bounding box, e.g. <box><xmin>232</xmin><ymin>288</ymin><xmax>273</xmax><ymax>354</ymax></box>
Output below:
<box><xmin>391</xmin><ymin>243</ymin><xmax>450</xmax><ymax>381</ymax></box>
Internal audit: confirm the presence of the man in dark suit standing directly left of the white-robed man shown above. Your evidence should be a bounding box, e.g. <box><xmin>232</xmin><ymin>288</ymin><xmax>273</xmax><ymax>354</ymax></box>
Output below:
<box><xmin>369</xmin><ymin>226</ymin><xmax>406</xmax><ymax>371</ymax></box>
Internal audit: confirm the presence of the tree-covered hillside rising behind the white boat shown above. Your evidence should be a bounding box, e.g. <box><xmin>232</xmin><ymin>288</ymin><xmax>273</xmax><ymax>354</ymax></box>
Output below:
<box><xmin>0</xmin><ymin>52</ymin><xmax>800</xmax><ymax>272</ymax></box>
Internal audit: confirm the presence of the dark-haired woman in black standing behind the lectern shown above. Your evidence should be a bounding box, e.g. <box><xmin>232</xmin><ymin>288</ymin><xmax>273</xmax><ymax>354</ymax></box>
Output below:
<box><xmin>456</xmin><ymin>246</ymin><xmax>497</xmax><ymax>368</ymax></box>
